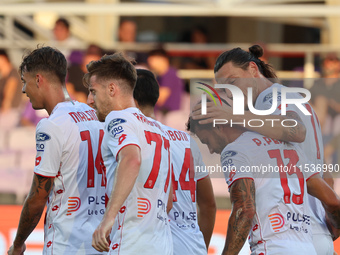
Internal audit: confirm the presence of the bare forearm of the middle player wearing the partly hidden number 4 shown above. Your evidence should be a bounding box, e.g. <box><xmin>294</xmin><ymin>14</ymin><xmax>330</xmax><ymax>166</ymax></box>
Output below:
<box><xmin>198</xmin><ymin>206</ymin><xmax>216</xmax><ymax>249</ymax></box>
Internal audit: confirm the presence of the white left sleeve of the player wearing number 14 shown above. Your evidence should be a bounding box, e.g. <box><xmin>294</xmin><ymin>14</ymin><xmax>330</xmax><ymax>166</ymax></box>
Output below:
<box><xmin>34</xmin><ymin>119</ymin><xmax>64</xmax><ymax>177</ymax></box>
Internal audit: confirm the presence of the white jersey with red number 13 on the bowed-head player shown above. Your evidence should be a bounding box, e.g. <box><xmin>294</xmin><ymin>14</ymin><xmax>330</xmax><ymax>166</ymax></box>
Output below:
<box><xmin>221</xmin><ymin>132</ymin><xmax>316</xmax><ymax>255</ymax></box>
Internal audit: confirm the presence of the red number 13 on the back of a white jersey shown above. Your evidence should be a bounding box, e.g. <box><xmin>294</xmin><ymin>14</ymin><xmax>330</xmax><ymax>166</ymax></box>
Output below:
<box><xmin>268</xmin><ymin>149</ymin><xmax>305</xmax><ymax>205</ymax></box>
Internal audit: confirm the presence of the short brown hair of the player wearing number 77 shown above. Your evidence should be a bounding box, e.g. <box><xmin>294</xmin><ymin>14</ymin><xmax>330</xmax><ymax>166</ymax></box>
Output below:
<box><xmin>83</xmin><ymin>52</ymin><xmax>137</xmax><ymax>91</ymax></box>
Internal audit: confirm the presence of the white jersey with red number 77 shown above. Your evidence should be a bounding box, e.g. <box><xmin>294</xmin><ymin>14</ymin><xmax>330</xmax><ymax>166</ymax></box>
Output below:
<box><xmin>102</xmin><ymin>108</ymin><xmax>173</xmax><ymax>255</ymax></box>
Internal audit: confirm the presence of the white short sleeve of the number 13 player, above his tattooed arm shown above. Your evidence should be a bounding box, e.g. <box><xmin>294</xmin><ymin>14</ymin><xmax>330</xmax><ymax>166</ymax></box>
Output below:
<box><xmin>221</xmin><ymin>149</ymin><xmax>254</xmax><ymax>188</ymax></box>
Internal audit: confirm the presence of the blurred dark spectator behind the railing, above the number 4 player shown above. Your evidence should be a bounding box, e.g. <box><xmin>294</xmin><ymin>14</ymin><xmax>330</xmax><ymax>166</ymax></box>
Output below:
<box><xmin>183</xmin><ymin>26</ymin><xmax>216</xmax><ymax>69</ymax></box>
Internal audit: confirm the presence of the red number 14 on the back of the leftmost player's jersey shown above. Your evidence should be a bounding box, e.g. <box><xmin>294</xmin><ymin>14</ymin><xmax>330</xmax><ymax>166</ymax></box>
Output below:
<box><xmin>80</xmin><ymin>129</ymin><xmax>106</xmax><ymax>188</ymax></box>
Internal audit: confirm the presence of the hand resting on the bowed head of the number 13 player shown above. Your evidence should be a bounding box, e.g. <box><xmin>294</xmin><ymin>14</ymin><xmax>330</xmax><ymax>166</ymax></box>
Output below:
<box><xmin>191</xmin><ymin>102</ymin><xmax>233</xmax><ymax>124</ymax></box>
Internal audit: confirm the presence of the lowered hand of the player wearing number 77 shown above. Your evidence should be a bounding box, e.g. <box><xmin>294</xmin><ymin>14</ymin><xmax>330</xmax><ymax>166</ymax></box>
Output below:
<box><xmin>92</xmin><ymin>217</ymin><xmax>114</xmax><ymax>252</ymax></box>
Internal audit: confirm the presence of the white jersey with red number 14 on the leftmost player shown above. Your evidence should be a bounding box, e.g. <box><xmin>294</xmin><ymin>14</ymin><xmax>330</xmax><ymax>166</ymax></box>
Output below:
<box><xmin>34</xmin><ymin>101</ymin><xmax>106</xmax><ymax>255</ymax></box>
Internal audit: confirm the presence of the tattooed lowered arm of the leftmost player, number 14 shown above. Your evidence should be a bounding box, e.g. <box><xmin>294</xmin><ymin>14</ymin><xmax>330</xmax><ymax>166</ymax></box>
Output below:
<box><xmin>8</xmin><ymin>174</ymin><xmax>54</xmax><ymax>255</ymax></box>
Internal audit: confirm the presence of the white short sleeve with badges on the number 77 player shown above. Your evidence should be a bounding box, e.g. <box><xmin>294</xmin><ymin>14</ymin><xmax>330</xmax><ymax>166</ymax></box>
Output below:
<box><xmin>105</xmin><ymin>112</ymin><xmax>141</xmax><ymax>161</ymax></box>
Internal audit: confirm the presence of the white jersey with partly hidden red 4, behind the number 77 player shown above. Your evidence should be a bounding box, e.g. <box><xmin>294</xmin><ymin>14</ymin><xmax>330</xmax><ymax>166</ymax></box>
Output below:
<box><xmin>161</xmin><ymin>124</ymin><xmax>209</xmax><ymax>255</ymax></box>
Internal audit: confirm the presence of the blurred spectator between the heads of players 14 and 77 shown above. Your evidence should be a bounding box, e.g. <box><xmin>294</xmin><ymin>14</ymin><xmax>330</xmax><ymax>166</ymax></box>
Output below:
<box><xmin>66</xmin><ymin>44</ymin><xmax>104</xmax><ymax>103</ymax></box>
